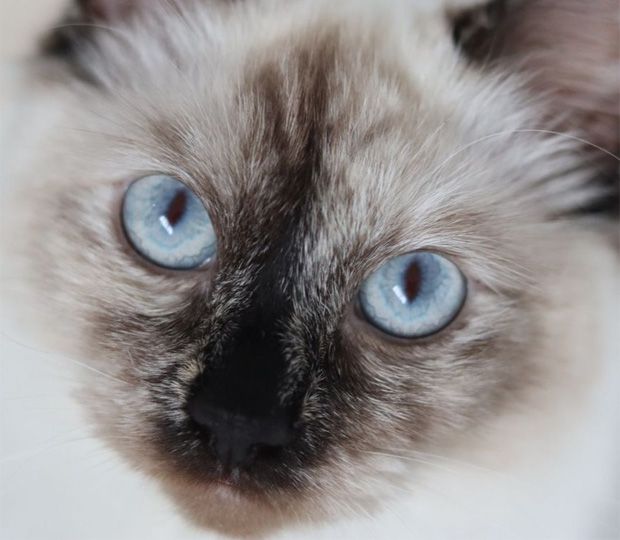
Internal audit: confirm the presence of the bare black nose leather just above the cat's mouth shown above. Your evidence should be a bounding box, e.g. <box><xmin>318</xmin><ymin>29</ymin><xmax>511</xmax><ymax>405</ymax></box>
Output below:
<box><xmin>188</xmin><ymin>389</ymin><xmax>293</xmax><ymax>467</ymax></box>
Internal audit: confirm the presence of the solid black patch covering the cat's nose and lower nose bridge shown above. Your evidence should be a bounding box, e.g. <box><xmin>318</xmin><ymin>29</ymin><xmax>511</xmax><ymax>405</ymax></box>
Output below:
<box><xmin>188</xmin><ymin>300</ymin><xmax>305</xmax><ymax>467</ymax></box>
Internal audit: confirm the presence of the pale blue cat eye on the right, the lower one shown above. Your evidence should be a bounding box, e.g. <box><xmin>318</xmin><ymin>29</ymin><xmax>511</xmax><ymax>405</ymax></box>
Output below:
<box><xmin>359</xmin><ymin>251</ymin><xmax>467</xmax><ymax>339</ymax></box>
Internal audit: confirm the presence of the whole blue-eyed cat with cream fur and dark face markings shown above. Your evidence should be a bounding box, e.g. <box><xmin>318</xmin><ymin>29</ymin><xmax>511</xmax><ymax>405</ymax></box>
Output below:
<box><xmin>0</xmin><ymin>0</ymin><xmax>619</xmax><ymax>538</ymax></box>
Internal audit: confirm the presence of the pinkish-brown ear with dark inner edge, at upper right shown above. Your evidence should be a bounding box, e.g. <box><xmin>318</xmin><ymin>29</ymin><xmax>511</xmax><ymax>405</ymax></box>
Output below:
<box><xmin>455</xmin><ymin>0</ymin><xmax>620</xmax><ymax>158</ymax></box>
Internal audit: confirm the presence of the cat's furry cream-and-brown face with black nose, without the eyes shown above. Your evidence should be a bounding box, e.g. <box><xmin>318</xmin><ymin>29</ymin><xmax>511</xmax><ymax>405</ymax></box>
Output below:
<box><xmin>21</xmin><ymin>2</ymin><xmax>604</xmax><ymax>524</ymax></box>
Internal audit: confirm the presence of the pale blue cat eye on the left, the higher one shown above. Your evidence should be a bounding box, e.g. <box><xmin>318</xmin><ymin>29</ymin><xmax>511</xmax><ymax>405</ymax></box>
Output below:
<box><xmin>122</xmin><ymin>175</ymin><xmax>216</xmax><ymax>270</ymax></box>
